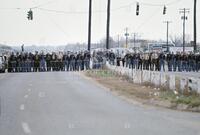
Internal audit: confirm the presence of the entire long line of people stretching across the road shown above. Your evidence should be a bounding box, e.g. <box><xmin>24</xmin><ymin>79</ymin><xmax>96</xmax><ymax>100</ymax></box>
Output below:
<box><xmin>5</xmin><ymin>50</ymin><xmax>200</xmax><ymax>72</ymax></box>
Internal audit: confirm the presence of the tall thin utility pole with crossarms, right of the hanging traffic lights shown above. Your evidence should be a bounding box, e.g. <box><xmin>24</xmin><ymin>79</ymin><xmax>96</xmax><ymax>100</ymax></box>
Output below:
<box><xmin>180</xmin><ymin>8</ymin><xmax>189</xmax><ymax>52</ymax></box>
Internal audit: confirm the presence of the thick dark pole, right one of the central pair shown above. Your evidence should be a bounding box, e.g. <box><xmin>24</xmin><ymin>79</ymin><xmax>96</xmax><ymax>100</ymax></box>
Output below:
<box><xmin>106</xmin><ymin>0</ymin><xmax>111</xmax><ymax>49</ymax></box>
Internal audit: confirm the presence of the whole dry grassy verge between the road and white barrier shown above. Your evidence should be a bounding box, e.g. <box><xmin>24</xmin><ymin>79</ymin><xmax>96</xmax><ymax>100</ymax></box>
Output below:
<box><xmin>86</xmin><ymin>69</ymin><xmax>200</xmax><ymax>109</ymax></box>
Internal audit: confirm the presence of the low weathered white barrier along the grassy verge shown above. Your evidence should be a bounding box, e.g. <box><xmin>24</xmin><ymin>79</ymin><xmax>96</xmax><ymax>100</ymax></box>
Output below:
<box><xmin>106</xmin><ymin>63</ymin><xmax>200</xmax><ymax>93</ymax></box>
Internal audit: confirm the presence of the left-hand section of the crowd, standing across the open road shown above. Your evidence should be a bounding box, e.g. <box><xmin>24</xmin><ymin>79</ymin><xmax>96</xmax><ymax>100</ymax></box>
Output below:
<box><xmin>8</xmin><ymin>51</ymin><xmax>91</xmax><ymax>72</ymax></box>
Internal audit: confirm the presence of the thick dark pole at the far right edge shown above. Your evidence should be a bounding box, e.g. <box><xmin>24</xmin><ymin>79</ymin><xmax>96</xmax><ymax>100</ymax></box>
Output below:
<box><xmin>194</xmin><ymin>0</ymin><xmax>197</xmax><ymax>52</ymax></box>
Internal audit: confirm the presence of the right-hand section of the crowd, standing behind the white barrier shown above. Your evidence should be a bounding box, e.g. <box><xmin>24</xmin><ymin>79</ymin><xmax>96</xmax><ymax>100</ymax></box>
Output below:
<box><xmin>109</xmin><ymin>52</ymin><xmax>200</xmax><ymax>72</ymax></box>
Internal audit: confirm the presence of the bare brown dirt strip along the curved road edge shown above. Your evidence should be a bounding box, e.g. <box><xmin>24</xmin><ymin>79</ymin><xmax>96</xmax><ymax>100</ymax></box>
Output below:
<box><xmin>84</xmin><ymin>72</ymin><xmax>200</xmax><ymax>112</ymax></box>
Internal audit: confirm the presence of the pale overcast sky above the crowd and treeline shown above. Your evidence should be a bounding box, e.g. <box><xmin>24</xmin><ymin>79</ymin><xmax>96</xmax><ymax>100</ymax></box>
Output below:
<box><xmin>0</xmin><ymin>0</ymin><xmax>200</xmax><ymax>45</ymax></box>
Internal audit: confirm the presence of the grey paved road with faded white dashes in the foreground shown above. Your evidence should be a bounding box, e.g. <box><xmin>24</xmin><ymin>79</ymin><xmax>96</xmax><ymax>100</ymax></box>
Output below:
<box><xmin>0</xmin><ymin>72</ymin><xmax>200</xmax><ymax>135</ymax></box>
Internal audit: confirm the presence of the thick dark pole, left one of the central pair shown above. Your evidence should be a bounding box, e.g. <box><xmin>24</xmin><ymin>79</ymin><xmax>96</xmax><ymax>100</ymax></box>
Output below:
<box><xmin>88</xmin><ymin>0</ymin><xmax>92</xmax><ymax>51</ymax></box>
